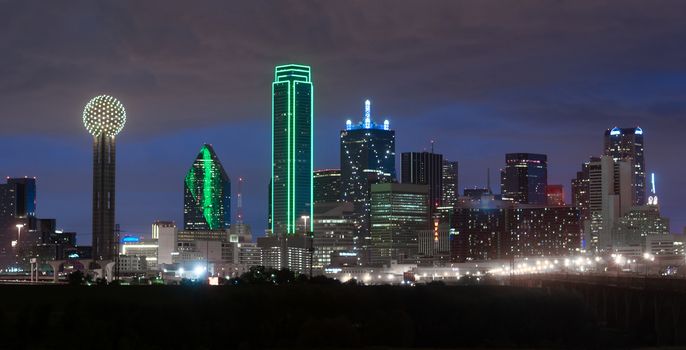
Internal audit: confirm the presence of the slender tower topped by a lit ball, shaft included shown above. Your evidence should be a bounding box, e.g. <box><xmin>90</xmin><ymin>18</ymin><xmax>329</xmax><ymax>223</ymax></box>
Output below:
<box><xmin>83</xmin><ymin>95</ymin><xmax>126</xmax><ymax>260</ymax></box>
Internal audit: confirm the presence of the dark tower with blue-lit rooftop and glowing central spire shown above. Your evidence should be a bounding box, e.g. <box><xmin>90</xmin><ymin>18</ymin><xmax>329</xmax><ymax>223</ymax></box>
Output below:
<box><xmin>340</xmin><ymin>100</ymin><xmax>396</xmax><ymax>249</ymax></box>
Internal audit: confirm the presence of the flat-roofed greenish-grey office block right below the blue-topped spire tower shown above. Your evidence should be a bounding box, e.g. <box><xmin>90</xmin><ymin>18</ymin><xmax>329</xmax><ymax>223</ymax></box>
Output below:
<box><xmin>371</xmin><ymin>183</ymin><xmax>429</xmax><ymax>264</ymax></box>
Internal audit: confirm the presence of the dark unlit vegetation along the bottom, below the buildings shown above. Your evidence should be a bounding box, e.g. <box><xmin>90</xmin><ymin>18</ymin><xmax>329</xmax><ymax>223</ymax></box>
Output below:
<box><xmin>0</xmin><ymin>284</ymin><xmax>636</xmax><ymax>349</ymax></box>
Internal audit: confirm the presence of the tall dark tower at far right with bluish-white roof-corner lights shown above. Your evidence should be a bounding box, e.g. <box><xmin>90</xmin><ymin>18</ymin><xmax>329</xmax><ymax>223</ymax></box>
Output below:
<box><xmin>605</xmin><ymin>127</ymin><xmax>646</xmax><ymax>205</ymax></box>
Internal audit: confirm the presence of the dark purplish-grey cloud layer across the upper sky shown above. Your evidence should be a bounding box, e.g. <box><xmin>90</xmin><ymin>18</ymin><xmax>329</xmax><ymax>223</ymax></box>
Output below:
<box><xmin>0</xmin><ymin>1</ymin><xmax>686</xmax><ymax>133</ymax></box>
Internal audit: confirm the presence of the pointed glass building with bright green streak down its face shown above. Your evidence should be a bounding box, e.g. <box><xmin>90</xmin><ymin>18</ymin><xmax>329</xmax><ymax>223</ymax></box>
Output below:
<box><xmin>183</xmin><ymin>144</ymin><xmax>231</xmax><ymax>230</ymax></box>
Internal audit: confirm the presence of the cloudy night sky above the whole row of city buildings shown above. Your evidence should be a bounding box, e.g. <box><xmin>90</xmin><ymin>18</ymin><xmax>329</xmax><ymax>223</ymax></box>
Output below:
<box><xmin>0</xmin><ymin>0</ymin><xmax>686</xmax><ymax>244</ymax></box>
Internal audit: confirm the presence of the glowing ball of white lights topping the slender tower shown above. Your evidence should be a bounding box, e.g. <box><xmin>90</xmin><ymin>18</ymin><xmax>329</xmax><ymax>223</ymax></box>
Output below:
<box><xmin>83</xmin><ymin>95</ymin><xmax>126</xmax><ymax>137</ymax></box>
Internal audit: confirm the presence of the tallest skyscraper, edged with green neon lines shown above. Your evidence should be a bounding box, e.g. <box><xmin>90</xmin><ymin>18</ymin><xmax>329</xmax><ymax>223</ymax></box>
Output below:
<box><xmin>270</xmin><ymin>64</ymin><xmax>313</xmax><ymax>235</ymax></box>
